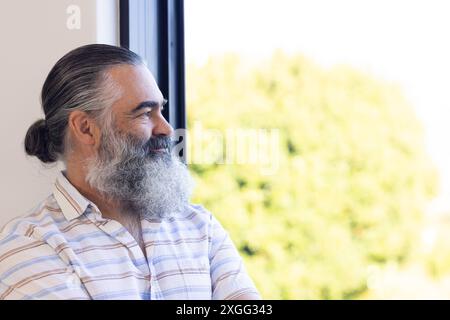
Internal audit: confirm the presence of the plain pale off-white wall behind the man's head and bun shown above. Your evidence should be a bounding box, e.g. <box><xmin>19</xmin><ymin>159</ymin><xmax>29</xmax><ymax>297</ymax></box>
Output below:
<box><xmin>0</xmin><ymin>0</ymin><xmax>118</xmax><ymax>226</ymax></box>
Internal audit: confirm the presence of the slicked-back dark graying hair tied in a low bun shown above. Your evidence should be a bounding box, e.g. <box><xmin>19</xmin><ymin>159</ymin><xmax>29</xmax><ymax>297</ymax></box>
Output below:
<box><xmin>24</xmin><ymin>44</ymin><xmax>144</xmax><ymax>163</ymax></box>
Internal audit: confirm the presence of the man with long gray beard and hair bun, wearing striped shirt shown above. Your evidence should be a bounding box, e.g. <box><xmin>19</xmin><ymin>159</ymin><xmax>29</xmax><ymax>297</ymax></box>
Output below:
<box><xmin>0</xmin><ymin>44</ymin><xmax>259</xmax><ymax>299</ymax></box>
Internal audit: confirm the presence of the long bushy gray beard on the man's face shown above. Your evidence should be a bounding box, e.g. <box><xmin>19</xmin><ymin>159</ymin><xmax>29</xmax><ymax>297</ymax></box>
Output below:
<box><xmin>86</xmin><ymin>133</ymin><xmax>193</xmax><ymax>220</ymax></box>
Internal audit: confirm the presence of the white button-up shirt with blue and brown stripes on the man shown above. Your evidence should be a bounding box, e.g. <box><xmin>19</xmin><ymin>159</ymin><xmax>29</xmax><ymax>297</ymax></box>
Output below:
<box><xmin>0</xmin><ymin>173</ymin><xmax>258</xmax><ymax>300</ymax></box>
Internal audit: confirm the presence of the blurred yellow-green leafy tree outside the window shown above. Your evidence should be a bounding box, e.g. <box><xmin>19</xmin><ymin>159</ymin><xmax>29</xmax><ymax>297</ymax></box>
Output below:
<box><xmin>187</xmin><ymin>52</ymin><xmax>436</xmax><ymax>299</ymax></box>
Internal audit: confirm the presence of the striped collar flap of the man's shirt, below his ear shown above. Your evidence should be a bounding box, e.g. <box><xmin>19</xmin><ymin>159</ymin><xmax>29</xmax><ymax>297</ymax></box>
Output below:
<box><xmin>53</xmin><ymin>171</ymin><xmax>95</xmax><ymax>221</ymax></box>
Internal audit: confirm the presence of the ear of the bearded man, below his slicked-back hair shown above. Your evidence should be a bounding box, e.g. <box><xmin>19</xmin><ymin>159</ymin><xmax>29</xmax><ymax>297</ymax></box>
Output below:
<box><xmin>68</xmin><ymin>110</ymin><xmax>100</xmax><ymax>147</ymax></box>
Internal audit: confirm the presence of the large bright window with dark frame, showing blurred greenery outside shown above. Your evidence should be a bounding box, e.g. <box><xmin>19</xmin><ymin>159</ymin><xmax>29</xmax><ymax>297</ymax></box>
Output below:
<box><xmin>122</xmin><ymin>0</ymin><xmax>450</xmax><ymax>299</ymax></box>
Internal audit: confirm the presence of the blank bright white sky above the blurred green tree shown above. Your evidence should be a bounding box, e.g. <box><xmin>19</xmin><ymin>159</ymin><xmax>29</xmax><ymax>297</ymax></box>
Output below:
<box><xmin>185</xmin><ymin>0</ymin><xmax>450</xmax><ymax>207</ymax></box>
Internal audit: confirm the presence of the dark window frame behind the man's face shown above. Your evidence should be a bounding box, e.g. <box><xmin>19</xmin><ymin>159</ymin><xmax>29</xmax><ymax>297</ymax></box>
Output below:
<box><xmin>119</xmin><ymin>0</ymin><xmax>186</xmax><ymax>129</ymax></box>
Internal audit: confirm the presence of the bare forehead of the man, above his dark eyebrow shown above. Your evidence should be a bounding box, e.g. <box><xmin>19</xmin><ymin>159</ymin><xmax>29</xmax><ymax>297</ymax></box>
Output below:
<box><xmin>109</xmin><ymin>65</ymin><xmax>164</xmax><ymax>110</ymax></box>
